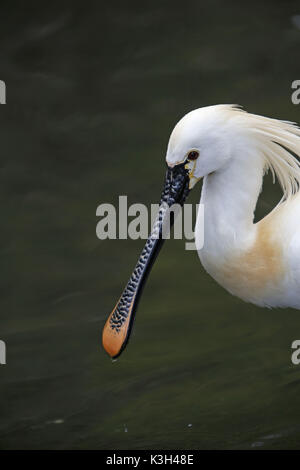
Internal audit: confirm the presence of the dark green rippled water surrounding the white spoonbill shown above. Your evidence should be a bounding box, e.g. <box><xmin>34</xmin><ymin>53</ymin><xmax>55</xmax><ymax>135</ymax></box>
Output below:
<box><xmin>0</xmin><ymin>0</ymin><xmax>300</xmax><ymax>449</ymax></box>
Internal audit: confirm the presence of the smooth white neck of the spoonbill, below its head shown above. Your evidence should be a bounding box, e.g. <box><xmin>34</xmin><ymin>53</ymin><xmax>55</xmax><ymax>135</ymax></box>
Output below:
<box><xmin>196</xmin><ymin>153</ymin><xmax>264</xmax><ymax>257</ymax></box>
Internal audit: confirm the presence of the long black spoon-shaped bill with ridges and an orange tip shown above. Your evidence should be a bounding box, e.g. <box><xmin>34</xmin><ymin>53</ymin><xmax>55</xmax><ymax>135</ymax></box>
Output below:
<box><xmin>102</xmin><ymin>164</ymin><xmax>189</xmax><ymax>358</ymax></box>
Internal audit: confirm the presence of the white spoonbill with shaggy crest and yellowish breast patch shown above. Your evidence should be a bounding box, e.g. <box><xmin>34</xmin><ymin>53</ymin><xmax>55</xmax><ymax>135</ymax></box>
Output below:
<box><xmin>102</xmin><ymin>104</ymin><xmax>300</xmax><ymax>358</ymax></box>
